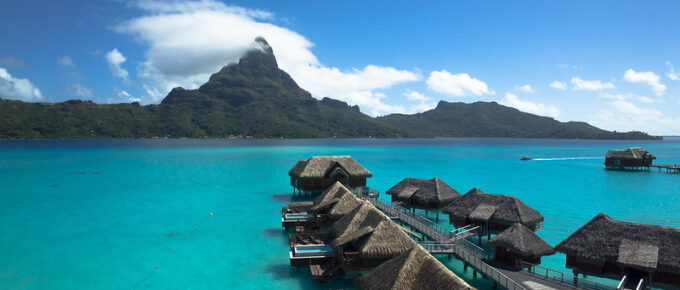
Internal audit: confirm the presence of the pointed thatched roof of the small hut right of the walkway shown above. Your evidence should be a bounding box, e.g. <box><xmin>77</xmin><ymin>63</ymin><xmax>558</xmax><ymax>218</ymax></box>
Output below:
<box><xmin>487</xmin><ymin>223</ymin><xmax>555</xmax><ymax>258</ymax></box>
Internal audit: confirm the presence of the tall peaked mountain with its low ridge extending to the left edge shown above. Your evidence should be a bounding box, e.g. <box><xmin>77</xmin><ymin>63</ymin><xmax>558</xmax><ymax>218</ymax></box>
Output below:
<box><xmin>0</xmin><ymin>38</ymin><xmax>409</xmax><ymax>139</ymax></box>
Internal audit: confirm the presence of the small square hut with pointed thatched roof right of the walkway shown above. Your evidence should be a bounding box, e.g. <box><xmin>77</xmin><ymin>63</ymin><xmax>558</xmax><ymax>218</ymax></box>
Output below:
<box><xmin>486</xmin><ymin>223</ymin><xmax>555</xmax><ymax>268</ymax></box>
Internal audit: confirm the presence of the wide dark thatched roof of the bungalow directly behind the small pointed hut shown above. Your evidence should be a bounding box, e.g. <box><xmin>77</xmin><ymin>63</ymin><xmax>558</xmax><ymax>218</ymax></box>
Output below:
<box><xmin>442</xmin><ymin>188</ymin><xmax>543</xmax><ymax>226</ymax></box>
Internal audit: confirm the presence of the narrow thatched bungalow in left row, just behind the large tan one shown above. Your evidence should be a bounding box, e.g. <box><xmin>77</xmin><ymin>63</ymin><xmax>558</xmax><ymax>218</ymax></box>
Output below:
<box><xmin>310</xmin><ymin>191</ymin><xmax>362</xmax><ymax>227</ymax></box>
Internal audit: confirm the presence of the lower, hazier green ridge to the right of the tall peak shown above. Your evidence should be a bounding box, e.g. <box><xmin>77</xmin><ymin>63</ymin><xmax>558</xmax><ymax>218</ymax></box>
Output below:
<box><xmin>378</xmin><ymin>101</ymin><xmax>654</xmax><ymax>139</ymax></box>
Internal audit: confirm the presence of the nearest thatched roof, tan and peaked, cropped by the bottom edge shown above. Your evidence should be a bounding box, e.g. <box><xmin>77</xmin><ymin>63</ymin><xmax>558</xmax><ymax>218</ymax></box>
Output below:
<box><xmin>355</xmin><ymin>245</ymin><xmax>474</xmax><ymax>290</ymax></box>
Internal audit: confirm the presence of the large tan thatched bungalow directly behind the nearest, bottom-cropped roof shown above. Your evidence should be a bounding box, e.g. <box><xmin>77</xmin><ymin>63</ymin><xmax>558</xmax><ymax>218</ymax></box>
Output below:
<box><xmin>331</xmin><ymin>202</ymin><xmax>416</xmax><ymax>272</ymax></box>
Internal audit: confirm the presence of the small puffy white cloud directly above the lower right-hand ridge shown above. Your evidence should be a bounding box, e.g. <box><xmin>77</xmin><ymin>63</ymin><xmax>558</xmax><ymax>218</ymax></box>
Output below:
<box><xmin>427</xmin><ymin>70</ymin><xmax>494</xmax><ymax>97</ymax></box>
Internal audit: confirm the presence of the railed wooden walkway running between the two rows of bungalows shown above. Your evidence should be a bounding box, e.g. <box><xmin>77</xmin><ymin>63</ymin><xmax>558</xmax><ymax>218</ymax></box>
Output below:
<box><xmin>368</xmin><ymin>199</ymin><xmax>615</xmax><ymax>290</ymax></box>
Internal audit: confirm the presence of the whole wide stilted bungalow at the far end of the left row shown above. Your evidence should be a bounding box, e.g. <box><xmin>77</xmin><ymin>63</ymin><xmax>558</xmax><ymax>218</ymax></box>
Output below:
<box><xmin>288</xmin><ymin>156</ymin><xmax>373</xmax><ymax>193</ymax></box>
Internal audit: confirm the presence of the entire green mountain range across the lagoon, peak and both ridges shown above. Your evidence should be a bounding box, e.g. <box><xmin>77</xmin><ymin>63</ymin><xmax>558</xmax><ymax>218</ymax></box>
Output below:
<box><xmin>0</xmin><ymin>38</ymin><xmax>654</xmax><ymax>139</ymax></box>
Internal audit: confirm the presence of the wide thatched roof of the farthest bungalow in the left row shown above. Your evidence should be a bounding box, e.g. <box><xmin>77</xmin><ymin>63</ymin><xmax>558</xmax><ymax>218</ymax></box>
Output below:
<box><xmin>288</xmin><ymin>156</ymin><xmax>373</xmax><ymax>178</ymax></box>
